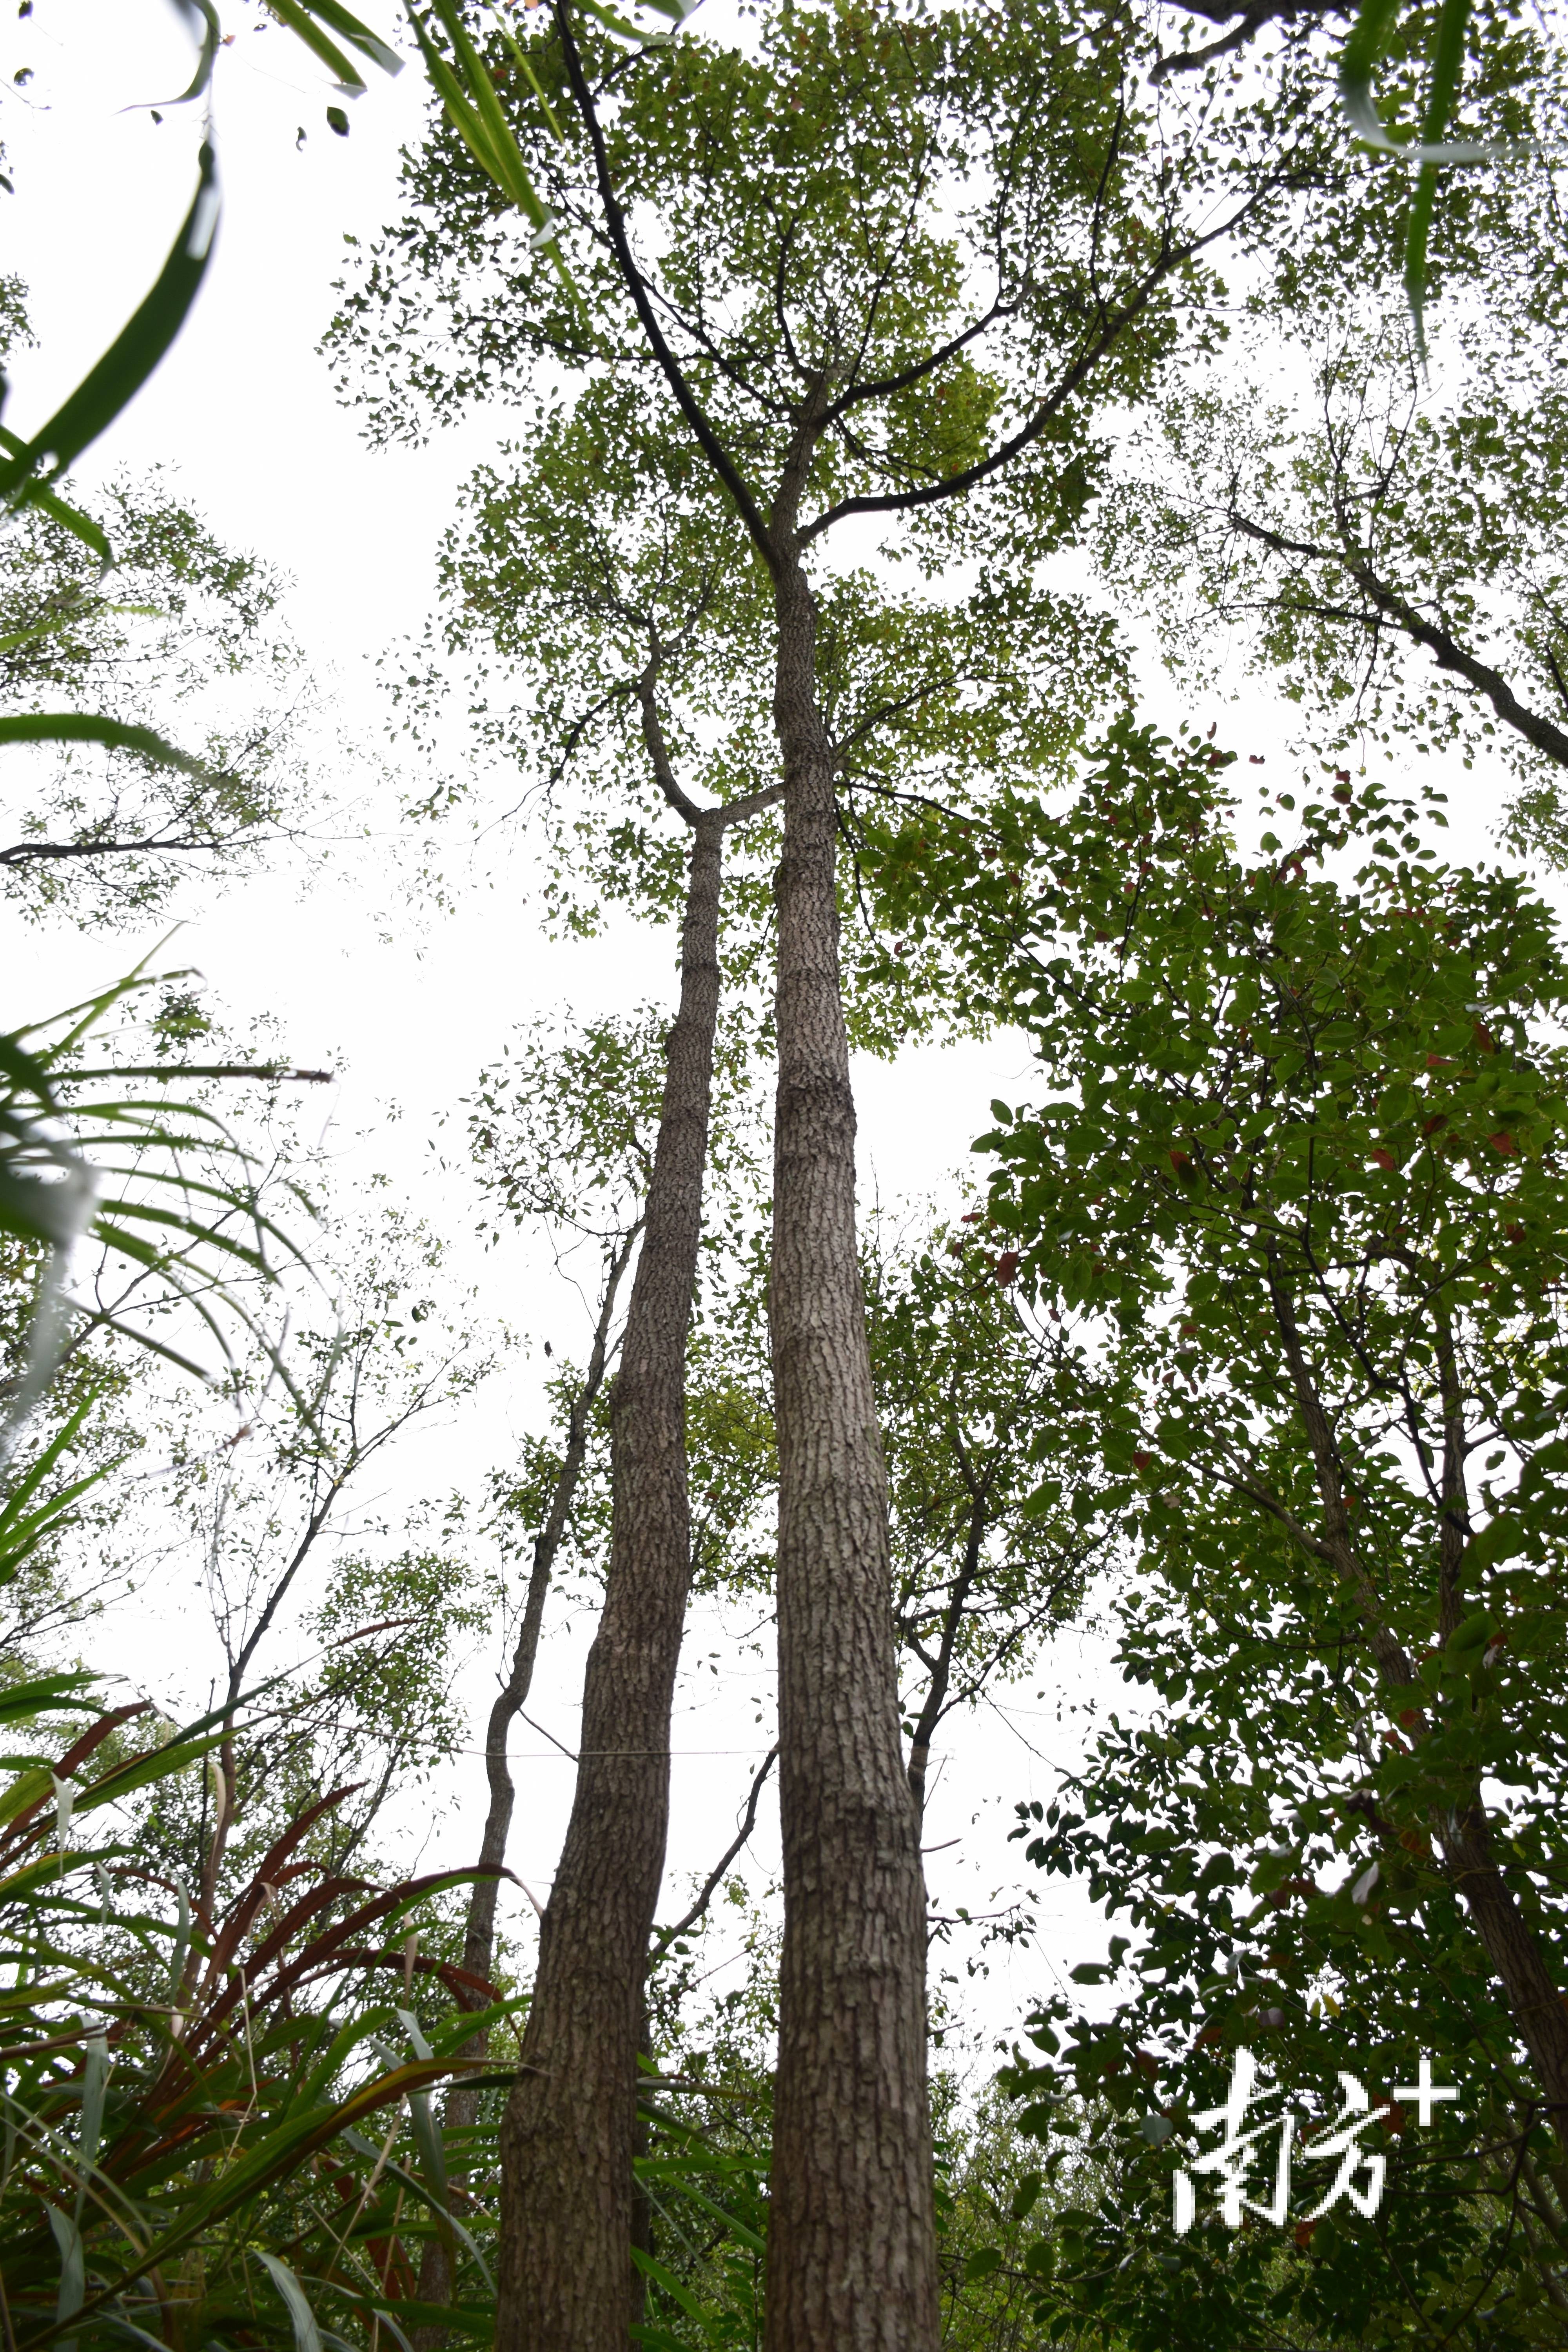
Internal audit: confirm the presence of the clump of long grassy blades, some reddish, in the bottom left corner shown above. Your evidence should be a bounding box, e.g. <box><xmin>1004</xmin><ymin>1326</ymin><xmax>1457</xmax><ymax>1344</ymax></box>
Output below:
<box><xmin>0</xmin><ymin>1675</ymin><xmax>505</xmax><ymax>2347</ymax></box>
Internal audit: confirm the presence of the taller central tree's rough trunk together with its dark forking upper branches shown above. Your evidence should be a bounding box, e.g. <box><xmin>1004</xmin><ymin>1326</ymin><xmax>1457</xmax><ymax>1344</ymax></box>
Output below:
<box><xmin>526</xmin><ymin>14</ymin><xmax>1260</xmax><ymax>2352</ymax></box>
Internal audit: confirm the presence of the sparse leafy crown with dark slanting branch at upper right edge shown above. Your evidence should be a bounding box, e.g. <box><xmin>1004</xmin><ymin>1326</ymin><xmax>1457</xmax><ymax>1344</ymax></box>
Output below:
<box><xmin>1098</xmin><ymin>299</ymin><xmax>1568</xmax><ymax>837</ymax></box>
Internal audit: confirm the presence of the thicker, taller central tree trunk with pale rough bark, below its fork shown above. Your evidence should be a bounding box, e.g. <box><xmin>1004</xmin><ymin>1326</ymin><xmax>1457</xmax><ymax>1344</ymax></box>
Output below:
<box><xmin>766</xmin><ymin>553</ymin><xmax>938</xmax><ymax>2352</ymax></box>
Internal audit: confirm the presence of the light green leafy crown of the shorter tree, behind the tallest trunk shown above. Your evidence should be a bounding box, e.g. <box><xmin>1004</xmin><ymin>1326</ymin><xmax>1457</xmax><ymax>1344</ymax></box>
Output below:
<box><xmin>392</xmin><ymin>358</ymin><xmax>1126</xmax><ymax>1058</ymax></box>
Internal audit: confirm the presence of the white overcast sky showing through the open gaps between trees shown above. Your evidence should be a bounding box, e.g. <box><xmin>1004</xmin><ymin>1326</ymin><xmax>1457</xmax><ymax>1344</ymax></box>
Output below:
<box><xmin>0</xmin><ymin>0</ymin><xmax>1523</xmax><ymax>2070</ymax></box>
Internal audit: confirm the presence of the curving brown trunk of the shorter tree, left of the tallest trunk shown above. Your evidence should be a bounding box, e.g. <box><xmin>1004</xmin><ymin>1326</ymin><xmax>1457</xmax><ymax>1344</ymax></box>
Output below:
<box><xmin>496</xmin><ymin>818</ymin><xmax>722</xmax><ymax>2352</ymax></box>
